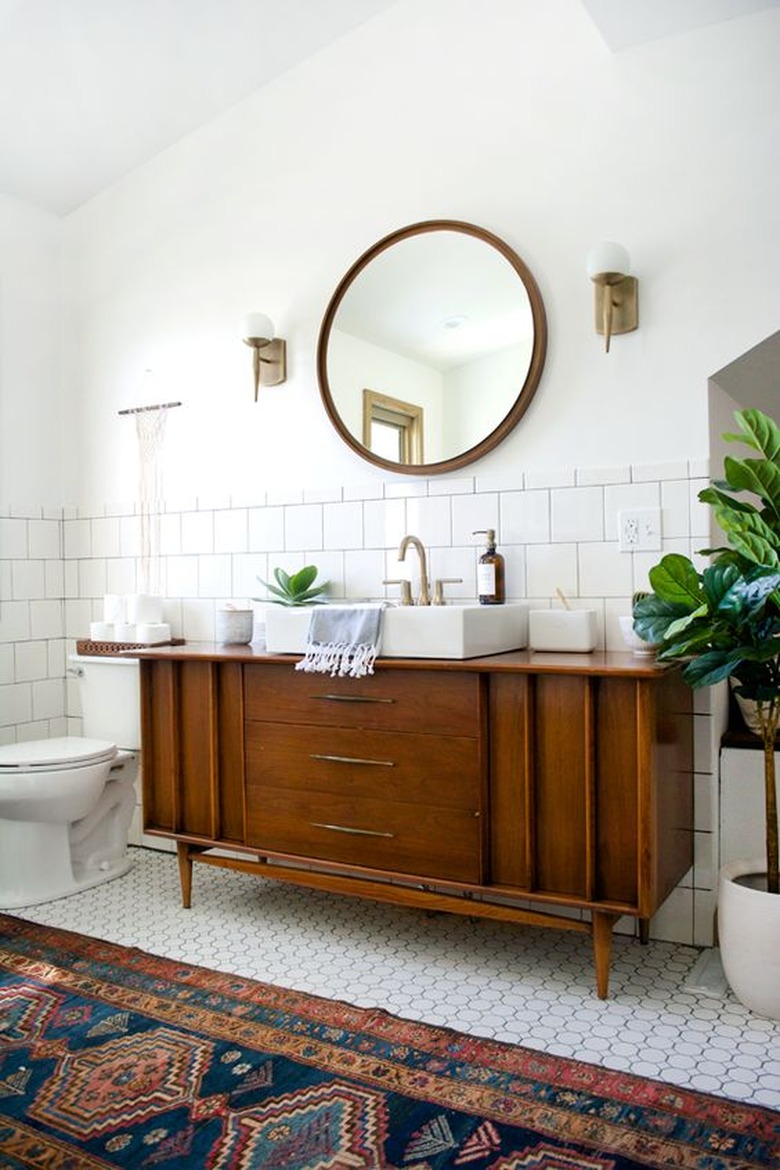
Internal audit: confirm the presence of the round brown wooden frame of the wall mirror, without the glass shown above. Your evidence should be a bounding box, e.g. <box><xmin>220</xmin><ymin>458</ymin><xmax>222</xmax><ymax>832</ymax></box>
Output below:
<box><xmin>317</xmin><ymin>220</ymin><xmax>547</xmax><ymax>475</ymax></box>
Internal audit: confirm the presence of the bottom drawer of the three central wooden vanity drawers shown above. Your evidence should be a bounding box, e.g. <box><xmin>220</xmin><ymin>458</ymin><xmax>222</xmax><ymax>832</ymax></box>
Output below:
<box><xmin>248</xmin><ymin>787</ymin><xmax>482</xmax><ymax>882</ymax></box>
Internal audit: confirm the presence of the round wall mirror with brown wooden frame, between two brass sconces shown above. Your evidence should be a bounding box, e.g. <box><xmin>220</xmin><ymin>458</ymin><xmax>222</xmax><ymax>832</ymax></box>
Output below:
<box><xmin>317</xmin><ymin>220</ymin><xmax>547</xmax><ymax>475</ymax></box>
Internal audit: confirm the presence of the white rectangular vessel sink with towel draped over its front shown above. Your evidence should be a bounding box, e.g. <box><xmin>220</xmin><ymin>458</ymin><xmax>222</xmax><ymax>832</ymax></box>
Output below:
<box><xmin>265</xmin><ymin>603</ymin><xmax>529</xmax><ymax>659</ymax></box>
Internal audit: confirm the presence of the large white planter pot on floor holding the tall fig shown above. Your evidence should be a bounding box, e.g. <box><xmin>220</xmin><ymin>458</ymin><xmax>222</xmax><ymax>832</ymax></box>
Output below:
<box><xmin>718</xmin><ymin>860</ymin><xmax>780</xmax><ymax>1019</ymax></box>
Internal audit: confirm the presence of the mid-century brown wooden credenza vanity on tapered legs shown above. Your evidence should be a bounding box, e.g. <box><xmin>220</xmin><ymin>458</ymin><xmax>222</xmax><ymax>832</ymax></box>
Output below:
<box><xmin>136</xmin><ymin>644</ymin><xmax>692</xmax><ymax>998</ymax></box>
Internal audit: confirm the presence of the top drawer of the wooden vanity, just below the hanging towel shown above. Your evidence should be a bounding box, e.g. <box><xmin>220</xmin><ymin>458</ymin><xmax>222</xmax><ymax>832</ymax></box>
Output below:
<box><xmin>244</xmin><ymin>663</ymin><xmax>483</xmax><ymax>736</ymax></box>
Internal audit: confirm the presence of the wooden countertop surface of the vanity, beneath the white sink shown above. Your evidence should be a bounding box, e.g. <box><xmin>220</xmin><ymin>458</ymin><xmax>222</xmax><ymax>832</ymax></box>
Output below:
<box><xmin>123</xmin><ymin>642</ymin><xmax>670</xmax><ymax>679</ymax></box>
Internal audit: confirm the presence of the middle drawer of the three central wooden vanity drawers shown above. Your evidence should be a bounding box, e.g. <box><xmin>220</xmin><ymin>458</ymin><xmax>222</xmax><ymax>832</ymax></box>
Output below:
<box><xmin>246</xmin><ymin>722</ymin><xmax>482</xmax><ymax>813</ymax></box>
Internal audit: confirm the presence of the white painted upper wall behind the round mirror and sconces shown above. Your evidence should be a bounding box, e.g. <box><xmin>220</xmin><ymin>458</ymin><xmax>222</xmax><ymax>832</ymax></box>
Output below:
<box><xmin>48</xmin><ymin>0</ymin><xmax>780</xmax><ymax>501</ymax></box>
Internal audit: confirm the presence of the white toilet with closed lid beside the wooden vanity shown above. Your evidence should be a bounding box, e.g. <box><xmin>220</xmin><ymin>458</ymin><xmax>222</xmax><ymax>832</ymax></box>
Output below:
<box><xmin>0</xmin><ymin>655</ymin><xmax>140</xmax><ymax>910</ymax></box>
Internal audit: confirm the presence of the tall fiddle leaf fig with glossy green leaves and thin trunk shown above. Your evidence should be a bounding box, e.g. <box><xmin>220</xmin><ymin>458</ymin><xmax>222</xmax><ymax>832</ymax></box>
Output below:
<box><xmin>634</xmin><ymin>410</ymin><xmax>780</xmax><ymax>894</ymax></box>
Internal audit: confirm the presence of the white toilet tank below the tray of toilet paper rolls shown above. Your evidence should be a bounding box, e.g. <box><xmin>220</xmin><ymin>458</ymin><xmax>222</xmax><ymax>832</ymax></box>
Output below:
<box><xmin>70</xmin><ymin>654</ymin><xmax>140</xmax><ymax>750</ymax></box>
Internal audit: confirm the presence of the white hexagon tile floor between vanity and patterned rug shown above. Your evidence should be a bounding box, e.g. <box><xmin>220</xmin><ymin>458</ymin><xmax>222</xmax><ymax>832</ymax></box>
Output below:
<box><xmin>6</xmin><ymin>848</ymin><xmax>780</xmax><ymax>1109</ymax></box>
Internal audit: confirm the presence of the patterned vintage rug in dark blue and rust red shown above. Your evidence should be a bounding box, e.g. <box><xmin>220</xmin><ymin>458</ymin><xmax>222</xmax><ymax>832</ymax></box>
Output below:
<box><xmin>0</xmin><ymin>915</ymin><xmax>780</xmax><ymax>1170</ymax></box>
